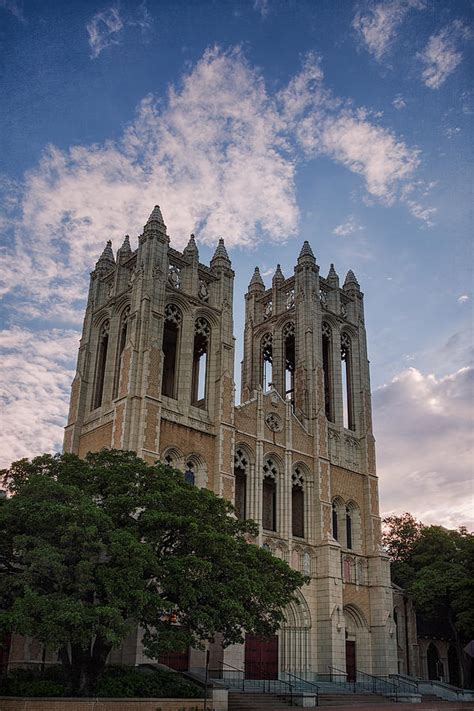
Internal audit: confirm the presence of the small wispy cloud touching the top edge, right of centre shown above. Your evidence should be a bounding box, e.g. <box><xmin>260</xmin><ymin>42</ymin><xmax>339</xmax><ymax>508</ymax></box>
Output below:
<box><xmin>352</xmin><ymin>0</ymin><xmax>425</xmax><ymax>61</ymax></box>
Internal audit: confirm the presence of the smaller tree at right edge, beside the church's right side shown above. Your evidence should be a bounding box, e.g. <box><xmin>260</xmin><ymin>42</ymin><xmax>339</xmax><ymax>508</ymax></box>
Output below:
<box><xmin>384</xmin><ymin>513</ymin><xmax>474</xmax><ymax>686</ymax></box>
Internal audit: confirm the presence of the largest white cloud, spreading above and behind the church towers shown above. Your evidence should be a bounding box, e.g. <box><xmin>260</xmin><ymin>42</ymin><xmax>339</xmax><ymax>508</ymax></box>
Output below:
<box><xmin>0</xmin><ymin>49</ymin><xmax>419</xmax><ymax>323</ymax></box>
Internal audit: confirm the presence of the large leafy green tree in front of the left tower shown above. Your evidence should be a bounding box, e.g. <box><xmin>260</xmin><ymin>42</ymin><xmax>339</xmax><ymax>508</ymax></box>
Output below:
<box><xmin>0</xmin><ymin>450</ymin><xmax>305</xmax><ymax>694</ymax></box>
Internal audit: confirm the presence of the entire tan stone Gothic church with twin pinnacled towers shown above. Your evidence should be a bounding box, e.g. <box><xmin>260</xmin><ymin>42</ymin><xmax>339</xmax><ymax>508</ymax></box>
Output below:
<box><xmin>64</xmin><ymin>207</ymin><xmax>397</xmax><ymax>675</ymax></box>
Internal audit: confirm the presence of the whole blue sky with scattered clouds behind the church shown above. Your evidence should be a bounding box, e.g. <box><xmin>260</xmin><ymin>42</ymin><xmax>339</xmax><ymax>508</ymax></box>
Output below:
<box><xmin>0</xmin><ymin>0</ymin><xmax>474</xmax><ymax>528</ymax></box>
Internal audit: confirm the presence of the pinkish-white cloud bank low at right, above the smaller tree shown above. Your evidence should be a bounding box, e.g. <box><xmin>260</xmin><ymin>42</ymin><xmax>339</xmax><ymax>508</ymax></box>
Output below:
<box><xmin>374</xmin><ymin>367</ymin><xmax>474</xmax><ymax>527</ymax></box>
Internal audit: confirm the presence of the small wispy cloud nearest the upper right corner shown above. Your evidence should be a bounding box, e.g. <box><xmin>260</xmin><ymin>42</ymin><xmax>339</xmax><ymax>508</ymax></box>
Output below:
<box><xmin>418</xmin><ymin>20</ymin><xmax>471</xmax><ymax>89</ymax></box>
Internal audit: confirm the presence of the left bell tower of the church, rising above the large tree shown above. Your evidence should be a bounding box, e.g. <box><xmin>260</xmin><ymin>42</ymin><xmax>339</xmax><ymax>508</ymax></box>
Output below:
<box><xmin>64</xmin><ymin>206</ymin><xmax>234</xmax><ymax>498</ymax></box>
